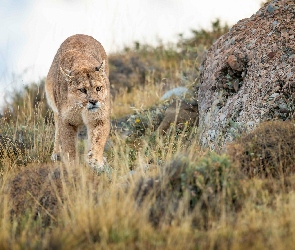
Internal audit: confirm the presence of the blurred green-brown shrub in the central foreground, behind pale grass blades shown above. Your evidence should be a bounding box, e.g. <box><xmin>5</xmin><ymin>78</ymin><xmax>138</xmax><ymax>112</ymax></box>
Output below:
<box><xmin>135</xmin><ymin>153</ymin><xmax>243</xmax><ymax>229</ymax></box>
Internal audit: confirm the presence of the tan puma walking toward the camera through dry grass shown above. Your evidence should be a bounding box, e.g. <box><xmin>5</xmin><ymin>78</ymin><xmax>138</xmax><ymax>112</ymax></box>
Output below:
<box><xmin>45</xmin><ymin>35</ymin><xmax>110</xmax><ymax>167</ymax></box>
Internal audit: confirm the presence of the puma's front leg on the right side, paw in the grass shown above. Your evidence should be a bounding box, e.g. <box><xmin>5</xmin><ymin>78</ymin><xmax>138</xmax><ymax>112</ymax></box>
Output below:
<box><xmin>87</xmin><ymin>122</ymin><xmax>110</xmax><ymax>170</ymax></box>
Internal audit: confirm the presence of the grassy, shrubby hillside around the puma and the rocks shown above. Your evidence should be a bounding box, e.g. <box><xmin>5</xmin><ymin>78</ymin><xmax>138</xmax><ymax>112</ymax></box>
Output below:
<box><xmin>0</xmin><ymin>21</ymin><xmax>295</xmax><ymax>249</ymax></box>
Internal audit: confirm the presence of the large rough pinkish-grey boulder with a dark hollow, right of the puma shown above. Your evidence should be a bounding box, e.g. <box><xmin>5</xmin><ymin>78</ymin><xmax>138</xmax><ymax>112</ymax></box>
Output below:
<box><xmin>198</xmin><ymin>0</ymin><xmax>295</xmax><ymax>149</ymax></box>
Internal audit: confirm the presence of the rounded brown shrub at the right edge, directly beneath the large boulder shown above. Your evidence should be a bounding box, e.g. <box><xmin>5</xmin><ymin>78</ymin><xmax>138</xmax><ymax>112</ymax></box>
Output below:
<box><xmin>228</xmin><ymin>121</ymin><xmax>295</xmax><ymax>178</ymax></box>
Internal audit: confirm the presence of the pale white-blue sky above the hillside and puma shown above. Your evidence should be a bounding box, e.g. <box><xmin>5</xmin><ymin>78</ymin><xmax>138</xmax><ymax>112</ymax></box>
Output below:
<box><xmin>0</xmin><ymin>0</ymin><xmax>262</xmax><ymax>105</ymax></box>
